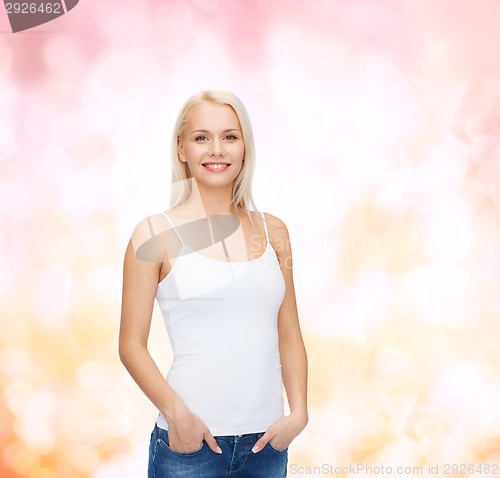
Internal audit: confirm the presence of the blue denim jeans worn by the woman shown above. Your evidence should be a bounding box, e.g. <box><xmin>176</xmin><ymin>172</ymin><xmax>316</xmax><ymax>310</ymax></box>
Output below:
<box><xmin>148</xmin><ymin>425</ymin><xmax>288</xmax><ymax>478</ymax></box>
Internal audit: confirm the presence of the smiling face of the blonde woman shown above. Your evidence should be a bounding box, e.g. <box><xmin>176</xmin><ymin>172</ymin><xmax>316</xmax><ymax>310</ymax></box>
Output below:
<box><xmin>177</xmin><ymin>102</ymin><xmax>245</xmax><ymax>187</ymax></box>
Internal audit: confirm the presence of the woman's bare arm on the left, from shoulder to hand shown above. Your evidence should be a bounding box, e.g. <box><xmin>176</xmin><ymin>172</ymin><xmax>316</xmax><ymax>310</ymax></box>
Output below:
<box><xmin>119</xmin><ymin>218</ymin><xmax>219</xmax><ymax>452</ymax></box>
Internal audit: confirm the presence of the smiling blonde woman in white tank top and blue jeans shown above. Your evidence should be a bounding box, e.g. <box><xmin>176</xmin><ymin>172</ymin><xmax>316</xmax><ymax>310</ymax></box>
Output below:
<box><xmin>119</xmin><ymin>90</ymin><xmax>308</xmax><ymax>478</ymax></box>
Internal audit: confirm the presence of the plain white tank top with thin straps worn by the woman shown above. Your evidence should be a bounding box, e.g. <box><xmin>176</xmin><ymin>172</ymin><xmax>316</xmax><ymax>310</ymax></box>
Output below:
<box><xmin>156</xmin><ymin>213</ymin><xmax>285</xmax><ymax>436</ymax></box>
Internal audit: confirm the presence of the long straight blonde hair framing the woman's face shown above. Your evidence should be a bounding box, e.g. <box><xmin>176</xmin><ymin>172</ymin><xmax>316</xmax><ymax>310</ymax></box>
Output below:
<box><xmin>170</xmin><ymin>90</ymin><xmax>257</xmax><ymax>220</ymax></box>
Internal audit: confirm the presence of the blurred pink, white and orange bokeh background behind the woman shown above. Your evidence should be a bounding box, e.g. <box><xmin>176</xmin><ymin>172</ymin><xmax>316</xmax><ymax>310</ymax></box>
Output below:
<box><xmin>0</xmin><ymin>0</ymin><xmax>500</xmax><ymax>478</ymax></box>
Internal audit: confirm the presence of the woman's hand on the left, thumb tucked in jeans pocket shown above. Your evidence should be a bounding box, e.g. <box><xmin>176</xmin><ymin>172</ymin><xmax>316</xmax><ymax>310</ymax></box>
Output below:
<box><xmin>167</xmin><ymin>400</ymin><xmax>222</xmax><ymax>453</ymax></box>
